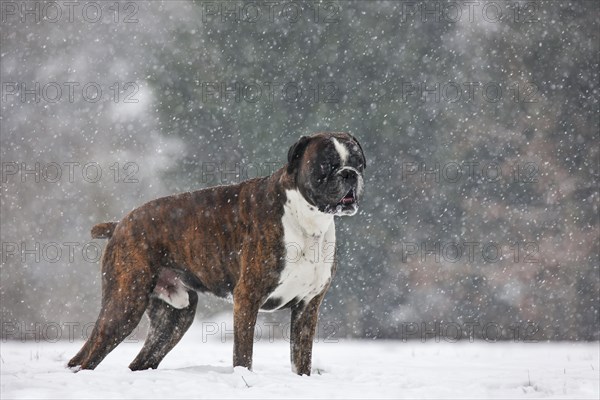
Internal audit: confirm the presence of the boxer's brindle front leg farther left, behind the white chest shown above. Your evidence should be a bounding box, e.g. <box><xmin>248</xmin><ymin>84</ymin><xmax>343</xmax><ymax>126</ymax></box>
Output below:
<box><xmin>233</xmin><ymin>284</ymin><xmax>260</xmax><ymax>369</ymax></box>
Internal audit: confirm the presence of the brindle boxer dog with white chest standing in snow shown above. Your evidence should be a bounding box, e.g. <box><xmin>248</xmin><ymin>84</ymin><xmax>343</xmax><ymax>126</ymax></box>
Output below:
<box><xmin>68</xmin><ymin>132</ymin><xmax>365</xmax><ymax>375</ymax></box>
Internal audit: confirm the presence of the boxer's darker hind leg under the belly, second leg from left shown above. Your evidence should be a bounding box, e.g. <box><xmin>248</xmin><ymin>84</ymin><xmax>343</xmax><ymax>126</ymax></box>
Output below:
<box><xmin>129</xmin><ymin>290</ymin><xmax>198</xmax><ymax>371</ymax></box>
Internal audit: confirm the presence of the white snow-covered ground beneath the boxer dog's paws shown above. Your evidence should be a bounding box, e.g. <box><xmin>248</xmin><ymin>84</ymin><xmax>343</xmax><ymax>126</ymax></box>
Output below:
<box><xmin>0</xmin><ymin>324</ymin><xmax>600</xmax><ymax>399</ymax></box>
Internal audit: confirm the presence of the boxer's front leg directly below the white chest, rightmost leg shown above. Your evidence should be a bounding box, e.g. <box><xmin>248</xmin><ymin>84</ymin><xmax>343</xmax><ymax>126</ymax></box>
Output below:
<box><xmin>290</xmin><ymin>294</ymin><xmax>323</xmax><ymax>375</ymax></box>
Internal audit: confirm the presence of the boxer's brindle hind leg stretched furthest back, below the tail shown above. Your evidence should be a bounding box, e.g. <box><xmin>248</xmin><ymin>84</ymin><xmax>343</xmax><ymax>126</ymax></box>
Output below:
<box><xmin>67</xmin><ymin>248</ymin><xmax>157</xmax><ymax>369</ymax></box>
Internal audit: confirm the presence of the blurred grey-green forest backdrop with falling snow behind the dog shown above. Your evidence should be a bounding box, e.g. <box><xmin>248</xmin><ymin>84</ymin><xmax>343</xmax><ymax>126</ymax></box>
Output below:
<box><xmin>0</xmin><ymin>1</ymin><xmax>600</xmax><ymax>340</ymax></box>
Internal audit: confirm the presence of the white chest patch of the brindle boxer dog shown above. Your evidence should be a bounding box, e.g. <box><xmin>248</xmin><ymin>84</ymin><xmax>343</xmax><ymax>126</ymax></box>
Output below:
<box><xmin>264</xmin><ymin>190</ymin><xmax>335</xmax><ymax>310</ymax></box>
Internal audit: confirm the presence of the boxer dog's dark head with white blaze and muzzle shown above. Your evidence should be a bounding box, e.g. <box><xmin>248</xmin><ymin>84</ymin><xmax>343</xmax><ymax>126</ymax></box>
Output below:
<box><xmin>287</xmin><ymin>132</ymin><xmax>366</xmax><ymax>215</ymax></box>
